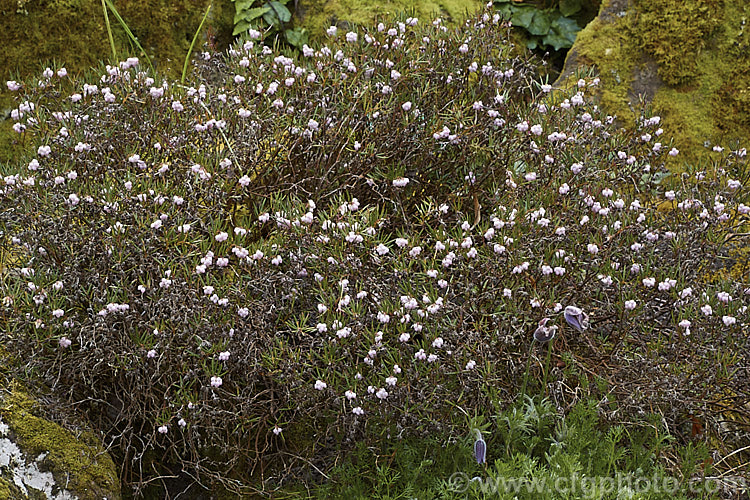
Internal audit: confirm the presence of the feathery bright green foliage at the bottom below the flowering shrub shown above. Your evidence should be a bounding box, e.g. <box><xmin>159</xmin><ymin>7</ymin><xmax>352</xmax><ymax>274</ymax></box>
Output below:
<box><xmin>302</xmin><ymin>397</ymin><xmax>741</xmax><ymax>499</ymax></box>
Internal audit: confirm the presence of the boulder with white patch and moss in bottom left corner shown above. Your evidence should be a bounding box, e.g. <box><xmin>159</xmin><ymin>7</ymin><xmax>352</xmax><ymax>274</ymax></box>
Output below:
<box><xmin>0</xmin><ymin>383</ymin><xmax>121</xmax><ymax>500</ymax></box>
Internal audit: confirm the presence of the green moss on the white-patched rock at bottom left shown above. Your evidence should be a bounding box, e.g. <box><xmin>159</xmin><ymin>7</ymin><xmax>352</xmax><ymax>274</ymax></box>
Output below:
<box><xmin>0</xmin><ymin>383</ymin><xmax>120</xmax><ymax>500</ymax></box>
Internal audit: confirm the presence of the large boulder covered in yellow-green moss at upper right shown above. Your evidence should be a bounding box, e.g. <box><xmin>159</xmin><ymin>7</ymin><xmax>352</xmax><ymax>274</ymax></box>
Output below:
<box><xmin>559</xmin><ymin>0</ymin><xmax>750</xmax><ymax>165</ymax></box>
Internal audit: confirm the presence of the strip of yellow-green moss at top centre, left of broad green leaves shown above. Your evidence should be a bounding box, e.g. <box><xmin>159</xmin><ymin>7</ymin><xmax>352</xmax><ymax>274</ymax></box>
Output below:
<box><xmin>297</xmin><ymin>0</ymin><xmax>482</xmax><ymax>37</ymax></box>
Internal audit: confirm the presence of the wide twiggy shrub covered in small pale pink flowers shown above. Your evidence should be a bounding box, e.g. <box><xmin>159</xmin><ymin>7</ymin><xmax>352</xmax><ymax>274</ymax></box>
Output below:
<box><xmin>0</xmin><ymin>4</ymin><xmax>750</xmax><ymax>491</ymax></box>
